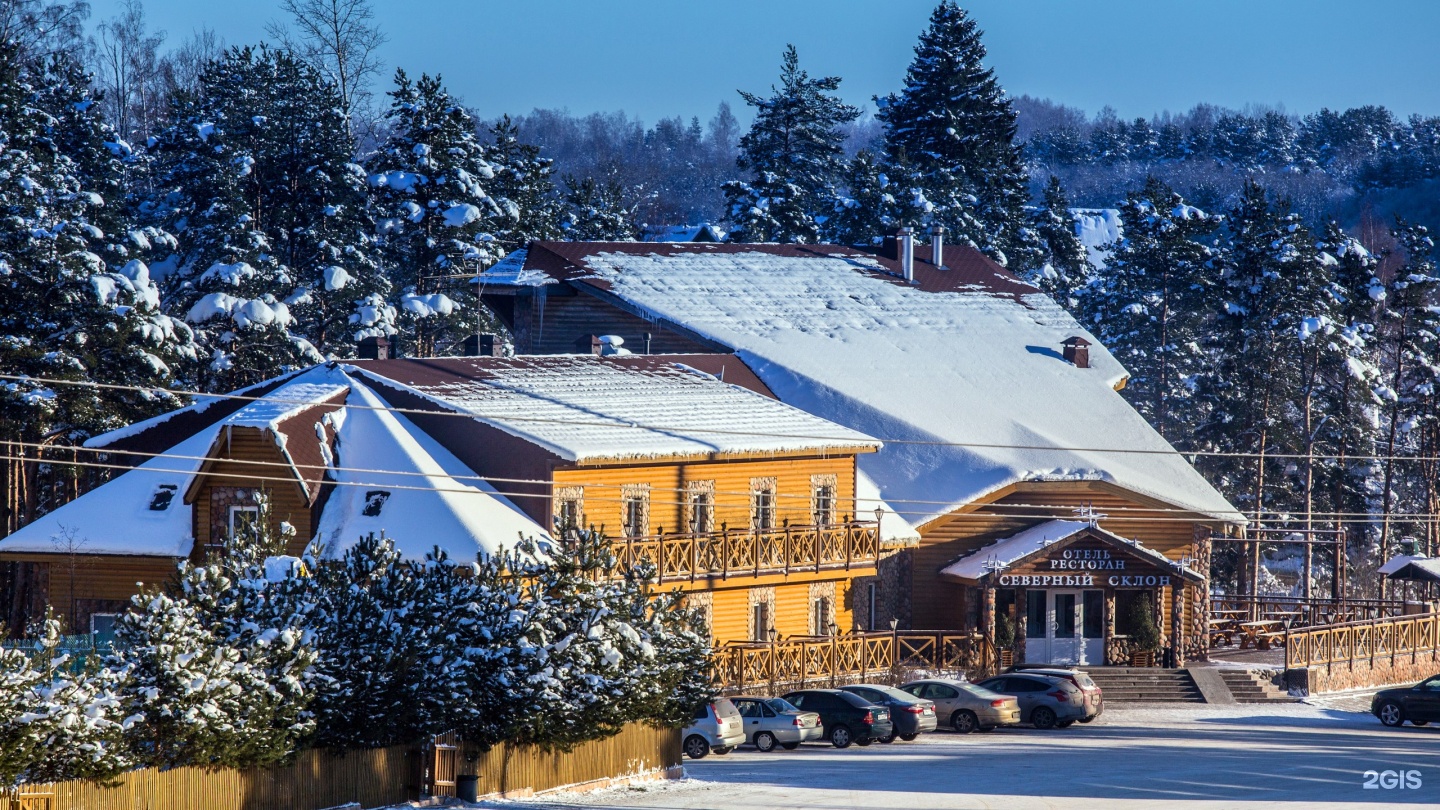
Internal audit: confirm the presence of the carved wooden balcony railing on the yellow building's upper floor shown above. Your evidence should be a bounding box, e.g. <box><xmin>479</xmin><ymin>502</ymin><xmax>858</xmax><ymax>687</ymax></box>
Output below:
<box><xmin>611</xmin><ymin>522</ymin><xmax>880</xmax><ymax>582</ymax></box>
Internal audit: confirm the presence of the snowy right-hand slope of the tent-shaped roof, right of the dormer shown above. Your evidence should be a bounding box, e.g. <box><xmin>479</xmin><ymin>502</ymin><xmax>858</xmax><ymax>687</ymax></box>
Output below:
<box><xmin>317</xmin><ymin>382</ymin><xmax>549</xmax><ymax>561</ymax></box>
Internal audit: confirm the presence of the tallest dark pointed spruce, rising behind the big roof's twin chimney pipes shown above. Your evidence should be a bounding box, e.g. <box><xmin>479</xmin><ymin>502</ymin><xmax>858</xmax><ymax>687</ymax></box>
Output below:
<box><xmin>876</xmin><ymin>0</ymin><xmax>1044</xmax><ymax>272</ymax></box>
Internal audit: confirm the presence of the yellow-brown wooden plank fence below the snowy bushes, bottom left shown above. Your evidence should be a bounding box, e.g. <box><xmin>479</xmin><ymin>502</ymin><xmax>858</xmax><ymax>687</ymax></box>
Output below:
<box><xmin>0</xmin><ymin>724</ymin><xmax>680</xmax><ymax>810</ymax></box>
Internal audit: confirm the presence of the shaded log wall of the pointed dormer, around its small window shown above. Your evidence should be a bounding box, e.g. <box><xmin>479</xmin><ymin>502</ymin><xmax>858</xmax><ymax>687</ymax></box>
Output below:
<box><xmin>190</xmin><ymin>427</ymin><xmax>314</xmax><ymax>555</ymax></box>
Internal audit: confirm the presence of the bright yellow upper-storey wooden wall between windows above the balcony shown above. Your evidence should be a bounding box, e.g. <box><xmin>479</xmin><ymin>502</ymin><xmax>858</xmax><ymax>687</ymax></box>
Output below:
<box><xmin>554</xmin><ymin>455</ymin><xmax>855</xmax><ymax>535</ymax></box>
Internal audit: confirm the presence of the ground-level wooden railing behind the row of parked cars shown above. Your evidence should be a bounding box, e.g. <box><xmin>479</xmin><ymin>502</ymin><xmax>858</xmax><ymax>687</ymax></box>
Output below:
<box><xmin>714</xmin><ymin>631</ymin><xmax>996</xmax><ymax>690</ymax></box>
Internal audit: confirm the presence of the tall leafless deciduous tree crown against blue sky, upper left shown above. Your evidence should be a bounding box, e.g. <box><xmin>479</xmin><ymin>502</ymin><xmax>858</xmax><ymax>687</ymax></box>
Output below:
<box><xmin>265</xmin><ymin>0</ymin><xmax>387</xmax><ymax>131</ymax></box>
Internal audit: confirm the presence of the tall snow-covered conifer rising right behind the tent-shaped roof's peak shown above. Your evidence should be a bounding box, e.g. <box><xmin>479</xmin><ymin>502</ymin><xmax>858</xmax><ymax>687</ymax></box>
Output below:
<box><xmin>368</xmin><ymin>71</ymin><xmax>504</xmax><ymax>357</ymax></box>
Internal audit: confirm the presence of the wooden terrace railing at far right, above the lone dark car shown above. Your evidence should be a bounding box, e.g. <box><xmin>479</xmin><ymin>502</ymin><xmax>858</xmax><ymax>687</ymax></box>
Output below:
<box><xmin>1284</xmin><ymin>613</ymin><xmax>1440</xmax><ymax>669</ymax></box>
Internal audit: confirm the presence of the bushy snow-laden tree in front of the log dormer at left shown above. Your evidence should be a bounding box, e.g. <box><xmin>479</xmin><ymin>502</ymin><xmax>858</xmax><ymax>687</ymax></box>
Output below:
<box><xmin>109</xmin><ymin>490</ymin><xmax>317</xmax><ymax>767</ymax></box>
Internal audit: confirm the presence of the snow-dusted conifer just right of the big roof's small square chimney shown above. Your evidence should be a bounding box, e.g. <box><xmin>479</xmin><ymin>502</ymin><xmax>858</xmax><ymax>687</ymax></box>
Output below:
<box><xmin>1076</xmin><ymin>179</ymin><xmax>1218</xmax><ymax>442</ymax></box>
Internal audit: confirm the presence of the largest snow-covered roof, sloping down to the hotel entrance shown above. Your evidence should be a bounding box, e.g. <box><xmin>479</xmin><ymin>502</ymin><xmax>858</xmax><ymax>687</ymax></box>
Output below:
<box><xmin>480</xmin><ymin>242</ymin><xmax>1243</xmax><ymax>526</ymax></box>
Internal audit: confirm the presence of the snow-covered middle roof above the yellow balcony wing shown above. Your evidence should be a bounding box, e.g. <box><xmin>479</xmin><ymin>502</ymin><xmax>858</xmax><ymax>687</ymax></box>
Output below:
<box><xmin>350</xmin><ymin>355</ymin><xmax>880</xmax><ymax>463</ymax></box>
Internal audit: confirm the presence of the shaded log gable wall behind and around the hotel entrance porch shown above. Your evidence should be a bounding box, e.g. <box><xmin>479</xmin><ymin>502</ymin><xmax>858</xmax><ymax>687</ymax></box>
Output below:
<box><xmin>910</xmin><ymin>481</ymin><xmax>1210</xmax><ymax>630</ymax></box>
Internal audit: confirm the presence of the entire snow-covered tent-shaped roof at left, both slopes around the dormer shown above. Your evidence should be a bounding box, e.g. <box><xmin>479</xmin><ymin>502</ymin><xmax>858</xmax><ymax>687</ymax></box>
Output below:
<box><xmin>0</xmin><ymin>366</ymin><xmax>547</xmax><ymax>561</ymax></box>
